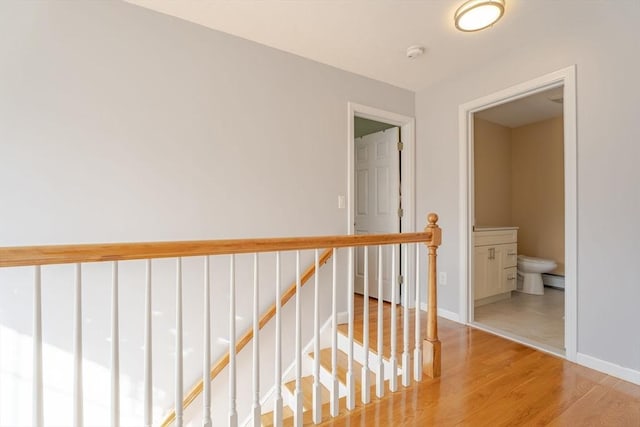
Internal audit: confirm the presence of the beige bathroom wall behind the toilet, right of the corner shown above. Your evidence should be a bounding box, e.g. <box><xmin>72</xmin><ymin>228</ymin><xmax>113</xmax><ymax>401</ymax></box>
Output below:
<box><xmin>511</xmin><ymin>117</ymin><xmax>564</xmax><ymax>274</ymax></box>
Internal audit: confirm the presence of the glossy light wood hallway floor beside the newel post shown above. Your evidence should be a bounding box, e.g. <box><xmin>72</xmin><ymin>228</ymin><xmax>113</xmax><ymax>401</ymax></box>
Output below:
<box><xmin>323</xmin><ymin>297</ymin><xmax>640</xmax><ymax>427</ymax></box>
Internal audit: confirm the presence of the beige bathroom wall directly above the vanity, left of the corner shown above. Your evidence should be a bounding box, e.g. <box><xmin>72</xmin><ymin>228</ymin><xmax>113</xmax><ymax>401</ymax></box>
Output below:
<box><xmin>474</xmin><ymin>118</ymin><xmax>513</xmax><ymax>225</ymax></box>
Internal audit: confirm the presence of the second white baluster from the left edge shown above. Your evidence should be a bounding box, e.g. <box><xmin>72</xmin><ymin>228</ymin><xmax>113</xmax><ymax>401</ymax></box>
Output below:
<box><xmin>73</xmin><ymin>264</ymin><xmax>84</xmax><ymax>427</ymax></box>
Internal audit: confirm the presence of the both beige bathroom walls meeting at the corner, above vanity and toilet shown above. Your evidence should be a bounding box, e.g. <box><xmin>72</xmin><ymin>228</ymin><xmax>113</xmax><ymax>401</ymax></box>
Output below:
<box><xmin>474</xmin><ymin>117</ymin><xmax>564</xmax><ymax>274</ymax></box>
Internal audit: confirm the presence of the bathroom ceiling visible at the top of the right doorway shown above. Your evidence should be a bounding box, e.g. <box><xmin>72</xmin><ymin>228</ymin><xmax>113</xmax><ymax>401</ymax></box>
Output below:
<box><xmin>476</xmin><ymin>87</ymin><xmax>563</xmax><ymax>128</ymax></box>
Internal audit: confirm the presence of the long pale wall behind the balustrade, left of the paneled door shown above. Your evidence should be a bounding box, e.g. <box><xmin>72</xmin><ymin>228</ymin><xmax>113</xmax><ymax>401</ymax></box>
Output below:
<box><xmin>0</xmin><ymin>1</ymin><xmax>414</xmax><ymax>424</ymax></box>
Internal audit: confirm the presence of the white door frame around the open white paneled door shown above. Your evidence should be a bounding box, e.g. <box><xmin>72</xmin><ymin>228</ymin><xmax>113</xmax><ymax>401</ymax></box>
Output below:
<box><xmin>347</xmin><ymin>102</ymin><xmax>416</xmax><ymax>307</ymax></box>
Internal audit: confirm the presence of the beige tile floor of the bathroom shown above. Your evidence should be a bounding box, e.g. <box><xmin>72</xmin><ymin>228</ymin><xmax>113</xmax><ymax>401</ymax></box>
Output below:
<box><xmin>474</xmin><ymin>287</ymin><xmax>564</xmax><ymax>352</ymax></box>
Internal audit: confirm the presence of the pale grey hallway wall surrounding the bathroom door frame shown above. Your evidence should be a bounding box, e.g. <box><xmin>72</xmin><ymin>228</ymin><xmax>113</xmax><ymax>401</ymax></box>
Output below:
<box><xmin>416</xmin><ymin>4</ymin><xmax>640</xmax><ymax>371</ymax></box>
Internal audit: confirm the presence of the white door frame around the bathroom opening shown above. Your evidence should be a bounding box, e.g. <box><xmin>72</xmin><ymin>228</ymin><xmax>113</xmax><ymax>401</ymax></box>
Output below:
<box><xmin>458</xmin><ymin>65</ymin><xmax>578</xmax><ymax>362</ymax></box>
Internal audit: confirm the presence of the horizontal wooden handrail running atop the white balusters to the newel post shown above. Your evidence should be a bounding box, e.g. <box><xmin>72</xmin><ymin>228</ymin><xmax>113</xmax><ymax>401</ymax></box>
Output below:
<box><xmin>0</xmin><ymin>231</ymin><xmax>432</xmax><ymax>267</ymax></box>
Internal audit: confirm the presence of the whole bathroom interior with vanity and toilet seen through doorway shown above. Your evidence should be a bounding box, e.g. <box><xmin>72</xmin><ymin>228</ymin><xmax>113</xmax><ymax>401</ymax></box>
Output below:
<box><xmin>472</xmin><ymin>87</ymin><xmax>565</xmax><ymax>354</ymax></box>
